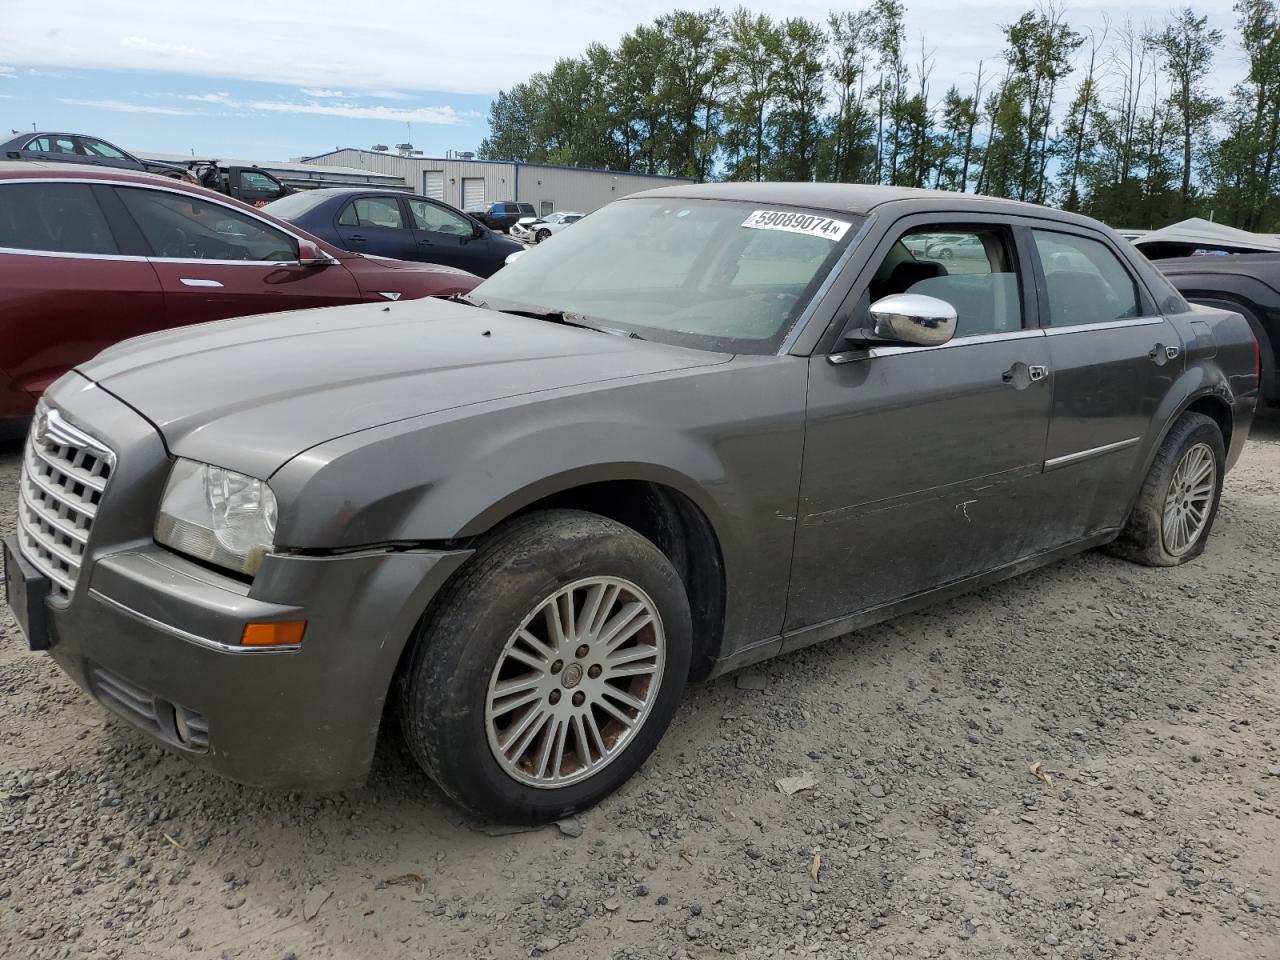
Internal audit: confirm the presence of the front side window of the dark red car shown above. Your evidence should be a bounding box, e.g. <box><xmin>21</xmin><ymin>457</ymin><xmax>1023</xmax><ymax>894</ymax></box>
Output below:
<box><xmin>116</xmin><ymin>187</ymin><xmax>298</xmax><ymax>261</ymax></box>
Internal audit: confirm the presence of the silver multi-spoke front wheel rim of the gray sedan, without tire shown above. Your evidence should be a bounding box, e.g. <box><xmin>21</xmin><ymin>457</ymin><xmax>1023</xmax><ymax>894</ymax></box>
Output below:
<box><xmin>485</xmin><ymin>576</ymin><xmax>667</xmax><ymax>788</ymax></box>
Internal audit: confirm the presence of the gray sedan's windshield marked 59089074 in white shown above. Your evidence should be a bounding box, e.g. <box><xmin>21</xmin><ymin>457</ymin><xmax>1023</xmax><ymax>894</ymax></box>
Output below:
<box><xmin>470</xmin><ymin>197</ymin><xmax>863</xmax><ymax>353</ymax></box>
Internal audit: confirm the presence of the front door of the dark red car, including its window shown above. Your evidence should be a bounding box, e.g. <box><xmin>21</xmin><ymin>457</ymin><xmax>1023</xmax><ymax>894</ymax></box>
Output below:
<box><xmin>113</xmin><ymin>187</ymin><xmax>361</xmax><ymax>326</ymax></box>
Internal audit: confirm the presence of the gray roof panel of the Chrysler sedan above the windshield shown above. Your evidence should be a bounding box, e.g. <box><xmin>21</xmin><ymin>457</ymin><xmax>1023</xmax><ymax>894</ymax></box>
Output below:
<box><xmin>628</xmin><ymin>182</ymin><xmax>1093</xmax><ymax>223</ymax></box>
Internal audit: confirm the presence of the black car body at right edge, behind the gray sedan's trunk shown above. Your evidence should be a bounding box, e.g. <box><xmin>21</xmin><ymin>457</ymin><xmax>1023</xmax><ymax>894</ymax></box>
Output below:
<box><xmin>1155</xmin><ymin>252</ymin><xmax>1280</xmax><ymax>403</ymax></box>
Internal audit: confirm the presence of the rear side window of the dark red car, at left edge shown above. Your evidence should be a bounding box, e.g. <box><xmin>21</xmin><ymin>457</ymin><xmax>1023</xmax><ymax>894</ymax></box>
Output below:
<box><xmin>0</xmin><ymin>183</ymin><xmax>119</xmax><ymax>255</ymax></box>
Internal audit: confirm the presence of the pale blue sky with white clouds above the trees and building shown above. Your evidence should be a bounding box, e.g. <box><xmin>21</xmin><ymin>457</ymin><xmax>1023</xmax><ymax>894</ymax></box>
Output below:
<box><xmin>0</xmin><ymin>0</ymin><xmax>1243</xmax><ymax>160</ymax></box>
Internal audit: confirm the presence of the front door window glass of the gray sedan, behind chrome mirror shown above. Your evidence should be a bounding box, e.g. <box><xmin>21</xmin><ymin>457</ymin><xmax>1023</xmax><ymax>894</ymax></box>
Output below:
<box><xmin>870</xmin><ymin>227</ymin><xmax>1023</xmax><ymax>337</ymax></box>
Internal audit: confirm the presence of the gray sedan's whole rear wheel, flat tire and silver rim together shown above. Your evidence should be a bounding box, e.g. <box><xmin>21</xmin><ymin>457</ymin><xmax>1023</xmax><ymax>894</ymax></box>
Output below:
<box><xmin>1108</xmin><ymin>413</ymin><xmax>1226</xmax><ymax>567</ymax></box>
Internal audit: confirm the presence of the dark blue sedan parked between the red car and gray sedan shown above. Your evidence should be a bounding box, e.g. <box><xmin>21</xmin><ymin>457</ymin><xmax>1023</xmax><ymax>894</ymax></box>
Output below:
<box><xmin>264</xmin><ymin>188</ymin><xmax>522</xmax><ymax>276</ymax></box>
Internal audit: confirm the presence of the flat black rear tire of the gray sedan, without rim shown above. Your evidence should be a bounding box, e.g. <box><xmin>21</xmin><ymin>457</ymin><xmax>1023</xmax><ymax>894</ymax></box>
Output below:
<box><xmin>1108</xmin><ymin>413</ymin><xmax>1226</xmax><ymax>567</ymax></box>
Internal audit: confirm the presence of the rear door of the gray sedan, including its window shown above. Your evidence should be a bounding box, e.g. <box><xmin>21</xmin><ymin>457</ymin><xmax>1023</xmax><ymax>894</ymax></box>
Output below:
<box><xmin>1029</xmin><ymin>224</ymin><xmax>1183</xmax><ymax>543</ymax></box>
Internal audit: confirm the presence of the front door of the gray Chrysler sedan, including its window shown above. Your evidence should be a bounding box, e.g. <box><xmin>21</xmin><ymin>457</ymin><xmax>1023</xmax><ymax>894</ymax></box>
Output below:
<box><xmin>786</xmin><ymin>223</ymin><xmax>1052</xmax><ymax>634</ymax></box>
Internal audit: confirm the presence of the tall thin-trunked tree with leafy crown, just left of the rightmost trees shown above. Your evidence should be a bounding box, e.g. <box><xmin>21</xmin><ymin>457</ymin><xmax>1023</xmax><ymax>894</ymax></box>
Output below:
<box><xmin>1149</xmin><ymin>6</ymin><xmax>1222</xmax><ymax>218</ymax></box>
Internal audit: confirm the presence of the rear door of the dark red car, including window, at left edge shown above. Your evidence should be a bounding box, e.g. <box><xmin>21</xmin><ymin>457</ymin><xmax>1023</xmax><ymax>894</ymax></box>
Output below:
<box><xmin>0</xmin><ymin>180</ymin><xmax>165</xmax><ymax>397</ymax></box>
